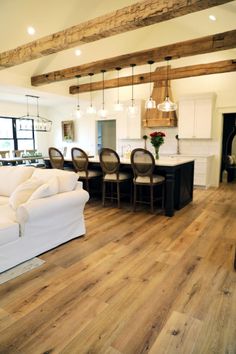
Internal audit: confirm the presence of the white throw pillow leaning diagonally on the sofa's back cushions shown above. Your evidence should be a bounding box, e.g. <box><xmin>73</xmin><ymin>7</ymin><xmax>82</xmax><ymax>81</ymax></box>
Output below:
<box><xmin>9</xmin><ymin>176</ymin><xmax>43</xmax><ymax>210</ymax></box>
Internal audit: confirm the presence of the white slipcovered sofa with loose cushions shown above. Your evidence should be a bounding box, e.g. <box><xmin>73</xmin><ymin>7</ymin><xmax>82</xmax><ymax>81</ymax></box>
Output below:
<box><xmin>0</xmin><ymin>166</ymin><xmax>89</xmax><ymax>273</ymax></box>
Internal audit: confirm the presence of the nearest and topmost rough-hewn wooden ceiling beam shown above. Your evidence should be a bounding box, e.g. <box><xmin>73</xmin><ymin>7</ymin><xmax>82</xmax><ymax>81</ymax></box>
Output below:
<box><xmin>0</xmin><ymin>0</ymin><xmax>232</xmax><ymax>69</ymax></box>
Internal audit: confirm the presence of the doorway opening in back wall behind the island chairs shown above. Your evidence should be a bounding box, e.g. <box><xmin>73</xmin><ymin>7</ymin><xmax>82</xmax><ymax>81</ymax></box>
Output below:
<box><xmin>97</xmin><ymin>119</ymin><xmax>116</xmax><ymax>154</ymax></box>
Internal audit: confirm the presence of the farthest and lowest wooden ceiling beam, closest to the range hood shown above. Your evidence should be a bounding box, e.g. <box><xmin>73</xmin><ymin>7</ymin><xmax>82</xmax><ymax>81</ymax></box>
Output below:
<box><xmin>69</xmin><ymin>59</ymin><xmax>236</xmax><ymax>95</ymax></box>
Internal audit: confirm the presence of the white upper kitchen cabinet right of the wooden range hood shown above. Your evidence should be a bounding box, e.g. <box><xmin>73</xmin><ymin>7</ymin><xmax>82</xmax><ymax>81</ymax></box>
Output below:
<box><xmin>178</xmin><ymin>93</ymin><xmax>215</xmax><ymax>139</ymax></box>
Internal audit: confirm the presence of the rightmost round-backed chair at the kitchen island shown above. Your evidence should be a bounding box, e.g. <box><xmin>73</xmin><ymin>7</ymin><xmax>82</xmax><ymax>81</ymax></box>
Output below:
<box><xmin>131</xmin><ymin>148</ymin><xmax>165</xmax><ymax>213</ymax></box>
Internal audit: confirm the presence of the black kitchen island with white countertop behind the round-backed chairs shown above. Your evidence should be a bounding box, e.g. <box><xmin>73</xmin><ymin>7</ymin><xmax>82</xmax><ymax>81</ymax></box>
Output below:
<box><xmin>44</xmin><ymin>156</ymin><xmax>194</xmax><ymax>216</ymax></box>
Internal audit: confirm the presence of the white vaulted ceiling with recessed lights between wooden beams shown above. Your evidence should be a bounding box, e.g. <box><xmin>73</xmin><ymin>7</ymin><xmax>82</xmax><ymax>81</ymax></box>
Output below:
<box><xmin>0</xmin><ymin>0</ymin><xmax>236</xmax><ymax>106</ymax></box>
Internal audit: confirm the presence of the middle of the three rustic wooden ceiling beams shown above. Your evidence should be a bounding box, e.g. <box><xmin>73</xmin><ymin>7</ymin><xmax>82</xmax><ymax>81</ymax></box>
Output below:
<box><xmin>31</xmin><ymin>30</ymin><xmax>236</xmax><ymax>86</ymax></box>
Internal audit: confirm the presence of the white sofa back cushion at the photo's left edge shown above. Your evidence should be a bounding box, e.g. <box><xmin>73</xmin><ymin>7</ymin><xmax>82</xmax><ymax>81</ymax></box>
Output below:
<box><xmin>0</xmin><ymin>166</ymin><xmax>35</xmax><ymax>197</ymax></box>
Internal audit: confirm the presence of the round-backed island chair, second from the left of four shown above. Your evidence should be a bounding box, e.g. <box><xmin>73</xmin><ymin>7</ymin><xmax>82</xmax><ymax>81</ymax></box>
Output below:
<box><xmin>71</xmin><ymin>147</ymin><xmax>102</xmax><ymax>192</ymax></box>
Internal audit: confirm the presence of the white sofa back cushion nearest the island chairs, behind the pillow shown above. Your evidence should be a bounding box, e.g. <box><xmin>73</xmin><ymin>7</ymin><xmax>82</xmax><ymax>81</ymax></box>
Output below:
<box><xmin>32</xmin><ymin>168</ymin><xmax>78</xmax><ymax>193</ymax></box>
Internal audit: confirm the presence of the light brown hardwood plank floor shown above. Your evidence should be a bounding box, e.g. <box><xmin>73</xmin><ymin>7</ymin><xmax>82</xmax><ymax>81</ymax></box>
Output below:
<box><xmin>0</xmin><ymin>184</ymin><xmax>236</xmax><ymax>354</ymax></box>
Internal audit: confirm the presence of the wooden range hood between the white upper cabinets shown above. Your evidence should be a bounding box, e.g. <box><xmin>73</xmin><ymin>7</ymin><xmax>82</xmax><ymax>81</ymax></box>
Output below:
<box><xmin>143</xmin><ymin>68</ymin><xmax>177</xmax><ymax>127</ymax></box>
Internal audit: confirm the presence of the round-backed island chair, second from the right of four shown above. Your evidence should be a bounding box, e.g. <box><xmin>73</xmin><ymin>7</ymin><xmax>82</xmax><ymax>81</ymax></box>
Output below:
<box><xmin>99</xmin><ymin>148</ymin><xmax>131</xmax><ymax>208</ymax></box>
